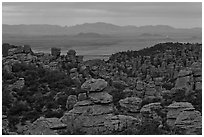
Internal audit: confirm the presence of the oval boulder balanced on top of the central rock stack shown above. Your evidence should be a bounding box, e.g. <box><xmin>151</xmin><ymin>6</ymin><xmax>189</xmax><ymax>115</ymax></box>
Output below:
<box><xmin>81</xmin><ymin>78</ymin><xmax>108</xmax><ymax>91</ymax></box>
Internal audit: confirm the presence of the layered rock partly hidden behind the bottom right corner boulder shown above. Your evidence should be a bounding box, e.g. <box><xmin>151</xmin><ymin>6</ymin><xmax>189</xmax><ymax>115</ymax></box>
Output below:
<box><xmin>167</xmin><ymin>102</ymin><xmax>194</xmax><ymax>127</ymax></box>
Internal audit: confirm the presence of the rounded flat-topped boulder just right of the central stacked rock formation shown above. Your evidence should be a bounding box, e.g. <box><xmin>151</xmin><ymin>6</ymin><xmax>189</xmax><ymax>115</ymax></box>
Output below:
<box><xmin>119</xmin><ymin>97</ymin><xmax>142</xmax><ymax>112</ymax></box>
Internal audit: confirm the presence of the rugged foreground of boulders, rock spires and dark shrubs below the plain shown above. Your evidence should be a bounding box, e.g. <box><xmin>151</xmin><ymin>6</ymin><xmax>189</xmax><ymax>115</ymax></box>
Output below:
<box><xmin>2</xmin><ymin>43</ymin><xmax>202</xmax><ymax>135</ymax></box>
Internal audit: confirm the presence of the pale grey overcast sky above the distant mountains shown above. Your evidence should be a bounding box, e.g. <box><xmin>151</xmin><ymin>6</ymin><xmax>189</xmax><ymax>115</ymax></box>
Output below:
<box><xmin>2</xmin><ymin>2</ymin><xmax>202</xmax><ymax>28</ymax></box>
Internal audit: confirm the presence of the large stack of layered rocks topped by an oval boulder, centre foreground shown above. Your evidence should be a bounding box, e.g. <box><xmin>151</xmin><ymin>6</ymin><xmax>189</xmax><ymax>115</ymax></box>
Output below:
<box><xmin>61</xmin><ymin>79</ymin><xmax>139</xmax><ymax>135</ymax></box>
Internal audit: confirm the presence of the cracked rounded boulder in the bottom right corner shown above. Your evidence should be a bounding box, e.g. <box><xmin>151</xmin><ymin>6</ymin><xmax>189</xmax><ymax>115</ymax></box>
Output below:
<box><xmin>175</xmin><ymin>110</ymin><xmax>202</xmax><ymax>135</ymax></box>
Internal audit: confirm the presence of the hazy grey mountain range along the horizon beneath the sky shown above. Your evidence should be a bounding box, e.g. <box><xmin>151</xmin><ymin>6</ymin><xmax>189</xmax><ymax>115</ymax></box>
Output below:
<box><xmin>2</xmin><ymin>22</ymin><xmax>202</xmax><ymax>37</ymax></box>
